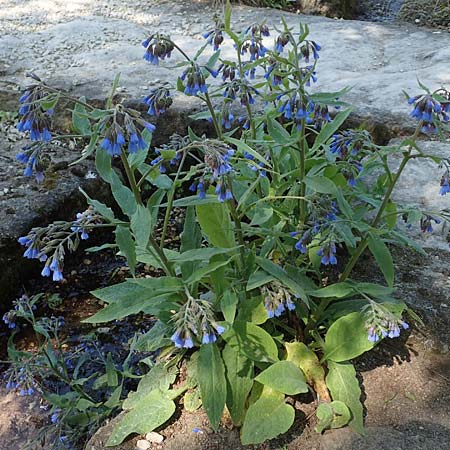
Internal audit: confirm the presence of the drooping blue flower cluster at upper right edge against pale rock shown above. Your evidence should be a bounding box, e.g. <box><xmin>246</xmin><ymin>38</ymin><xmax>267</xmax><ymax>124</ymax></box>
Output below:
<box><xmin>408</xmin><ymin>90</ymin><xmax>450</xmax><ymax>133</ymax></box>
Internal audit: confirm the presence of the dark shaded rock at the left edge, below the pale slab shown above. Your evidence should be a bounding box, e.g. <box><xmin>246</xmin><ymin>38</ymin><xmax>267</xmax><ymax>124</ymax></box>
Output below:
<box><xmin>0</xmin><ymin>129</ymin><xmax>109</xmax><ymax>312</ymax></box>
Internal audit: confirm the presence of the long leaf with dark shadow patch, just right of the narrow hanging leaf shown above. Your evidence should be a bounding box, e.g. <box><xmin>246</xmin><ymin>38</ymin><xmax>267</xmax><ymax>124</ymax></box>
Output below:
<box><xmin>222</xmin><ymin>345</ymin><xmax>253</xmax><ymax>426</ymax></box>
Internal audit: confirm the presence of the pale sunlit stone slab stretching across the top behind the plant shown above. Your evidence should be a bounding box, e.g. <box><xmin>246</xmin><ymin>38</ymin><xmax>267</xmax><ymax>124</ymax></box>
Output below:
<box><xmin>0</xmin><ymin>0</ymin><xmax>450</xmax><ymax>137</ymax></box>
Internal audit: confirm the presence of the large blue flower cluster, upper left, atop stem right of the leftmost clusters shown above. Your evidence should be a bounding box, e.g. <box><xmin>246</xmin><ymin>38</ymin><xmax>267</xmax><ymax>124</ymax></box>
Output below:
<box><xmin>100</xmin><ymin>104</ymin><xmax>155</xmax><ymax>156</ymax></box>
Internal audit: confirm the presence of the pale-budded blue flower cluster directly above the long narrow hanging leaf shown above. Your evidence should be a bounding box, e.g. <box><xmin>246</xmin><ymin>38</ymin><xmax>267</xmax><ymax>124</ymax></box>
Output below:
<box><xmin>171</xmin><ymin>297</ymin><xmax>225</xmax><ymax>348</ymax></box>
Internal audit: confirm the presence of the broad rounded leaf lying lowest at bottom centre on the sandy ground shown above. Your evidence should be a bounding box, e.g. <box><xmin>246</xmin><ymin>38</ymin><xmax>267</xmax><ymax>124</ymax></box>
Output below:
<box><xmin>241</xmin><ymin>397</ymin><xmax>295</xmax><ymax>445</ymax></box>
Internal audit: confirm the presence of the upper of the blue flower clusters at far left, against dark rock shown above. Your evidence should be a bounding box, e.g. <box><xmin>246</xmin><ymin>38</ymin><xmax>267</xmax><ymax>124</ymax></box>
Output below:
<box><xmin>17</xmin><ymin>74</ymin><xmax>58</xmax><ymax>142</ymax></box>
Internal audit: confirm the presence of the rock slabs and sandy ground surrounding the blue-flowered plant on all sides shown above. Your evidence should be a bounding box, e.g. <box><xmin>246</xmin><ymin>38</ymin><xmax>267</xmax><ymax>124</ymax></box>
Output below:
<box><xmin>0</xmin><ymin>0</ymin><xmax>450</xmax><ymax>450</ymax></box>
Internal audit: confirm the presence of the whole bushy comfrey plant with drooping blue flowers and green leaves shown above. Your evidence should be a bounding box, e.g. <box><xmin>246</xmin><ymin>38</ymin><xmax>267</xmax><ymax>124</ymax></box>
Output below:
<box><xmin>11</xmin><ymin>2</ymin><xmax>450</xmax><ymax>445</ymax></box>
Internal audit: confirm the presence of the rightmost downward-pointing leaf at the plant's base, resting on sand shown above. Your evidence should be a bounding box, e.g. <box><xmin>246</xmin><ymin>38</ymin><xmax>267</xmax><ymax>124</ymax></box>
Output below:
<box><xmin>326</xmin><ymin>361</ymin><xmax>365</xmax><ymax>434</ymax></box>
